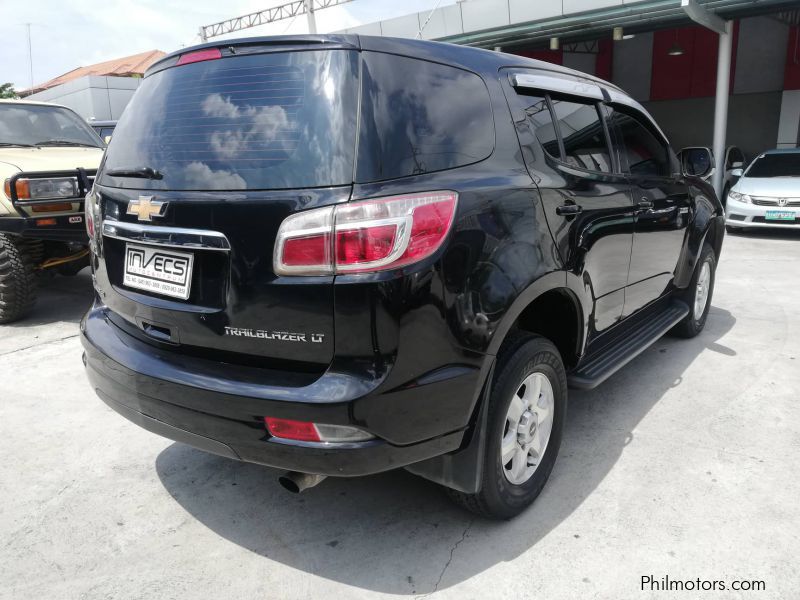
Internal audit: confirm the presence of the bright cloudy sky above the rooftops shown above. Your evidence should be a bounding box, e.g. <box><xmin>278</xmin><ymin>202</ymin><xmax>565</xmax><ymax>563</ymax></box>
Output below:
<box><xmin>0</xmin><ymin>0</ymin><xmax>455</xmax><ymax>89</ymax></box>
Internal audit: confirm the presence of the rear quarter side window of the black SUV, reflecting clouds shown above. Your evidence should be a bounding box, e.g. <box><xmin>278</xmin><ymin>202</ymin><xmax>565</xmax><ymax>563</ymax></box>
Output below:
<box><xmin>356</xmin><ymin>52</ymin><xmax>494</xmax><ymax>182</ymax></box>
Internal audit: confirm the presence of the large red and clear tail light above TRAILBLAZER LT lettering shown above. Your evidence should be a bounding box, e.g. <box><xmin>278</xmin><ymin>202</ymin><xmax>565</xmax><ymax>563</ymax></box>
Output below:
<box><xmin>273</xmin><ymin>191</ymin><xmax>458</xmax><ymax>275</ymax></box>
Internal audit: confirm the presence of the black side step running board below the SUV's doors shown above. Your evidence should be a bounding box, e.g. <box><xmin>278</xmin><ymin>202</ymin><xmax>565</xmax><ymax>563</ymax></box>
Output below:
<box><xmin>567</xmin><ymin>300</ymin><xmax>689</xmax><ymax>390</ymax></box>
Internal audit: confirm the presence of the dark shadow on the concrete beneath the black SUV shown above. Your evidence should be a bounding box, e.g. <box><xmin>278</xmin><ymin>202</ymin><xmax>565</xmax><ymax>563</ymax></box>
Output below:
<box><xmin>156</xmin><ymin>307</ymin><xmax>736</xmax><ymax>594</ymax></box>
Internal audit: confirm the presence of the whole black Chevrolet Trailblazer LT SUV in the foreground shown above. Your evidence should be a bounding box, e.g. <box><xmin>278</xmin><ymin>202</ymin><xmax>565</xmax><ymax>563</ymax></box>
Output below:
<box><xmin>81</xmin><ymin>35</ymin><xmax>723</xmax><ymax>518</ymax></box>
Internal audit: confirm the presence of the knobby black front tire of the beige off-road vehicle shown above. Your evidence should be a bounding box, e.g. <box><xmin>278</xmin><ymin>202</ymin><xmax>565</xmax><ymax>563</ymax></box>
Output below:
<box><xmin>0</xmin><ymin>233</ymin><xmax>40</xmax><ymax>324</ymax></box>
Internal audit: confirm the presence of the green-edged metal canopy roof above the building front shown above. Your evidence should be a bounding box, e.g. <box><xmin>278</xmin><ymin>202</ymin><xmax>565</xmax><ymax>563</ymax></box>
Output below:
<box><xmin>437</xmin><ymin>0</ymin><xmax>797</xmax><ymax>48</ymax></box>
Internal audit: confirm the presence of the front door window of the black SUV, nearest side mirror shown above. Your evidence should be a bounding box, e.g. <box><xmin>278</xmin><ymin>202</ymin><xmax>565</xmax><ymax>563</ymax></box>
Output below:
<box><xmin>611</xmin><ymin>110</ymin><xmax>671</xmax><ymax>176</ymax></box>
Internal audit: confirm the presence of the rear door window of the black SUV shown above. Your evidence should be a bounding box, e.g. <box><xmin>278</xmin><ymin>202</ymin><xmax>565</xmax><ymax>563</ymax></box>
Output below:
<box><xmin>552</xmin><ymin>98</ymin><xmax>613</xmax><ymax>173</ymax></box>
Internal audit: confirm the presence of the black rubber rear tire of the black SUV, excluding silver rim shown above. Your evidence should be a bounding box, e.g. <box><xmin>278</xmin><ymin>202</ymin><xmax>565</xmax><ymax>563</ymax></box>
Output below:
<box><xmin>448</xmin><ymin>332</ymin><xmax>567</xmax><ymax>519</ymax></box>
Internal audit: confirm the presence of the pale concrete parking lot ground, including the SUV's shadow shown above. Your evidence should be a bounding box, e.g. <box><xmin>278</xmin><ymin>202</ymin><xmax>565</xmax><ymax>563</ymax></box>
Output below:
<box><xmin>0</xmin><ymin>231</ymin><xmax>800</xmax><ymax>600</ymax></box>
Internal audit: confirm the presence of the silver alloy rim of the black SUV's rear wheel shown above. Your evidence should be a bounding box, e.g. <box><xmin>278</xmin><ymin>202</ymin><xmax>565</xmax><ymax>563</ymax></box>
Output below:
<box><xmin>500</xmin><ymin>373</ymin><xmax>555</xmax><ymax>485</ymax></box>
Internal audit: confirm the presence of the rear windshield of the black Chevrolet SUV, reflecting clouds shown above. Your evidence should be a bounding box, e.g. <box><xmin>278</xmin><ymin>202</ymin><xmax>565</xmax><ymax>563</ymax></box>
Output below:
<box><xmin>100</xmin><ymin>50</ymin><xmax>358</xmax><ymax>190</ymax></box>
